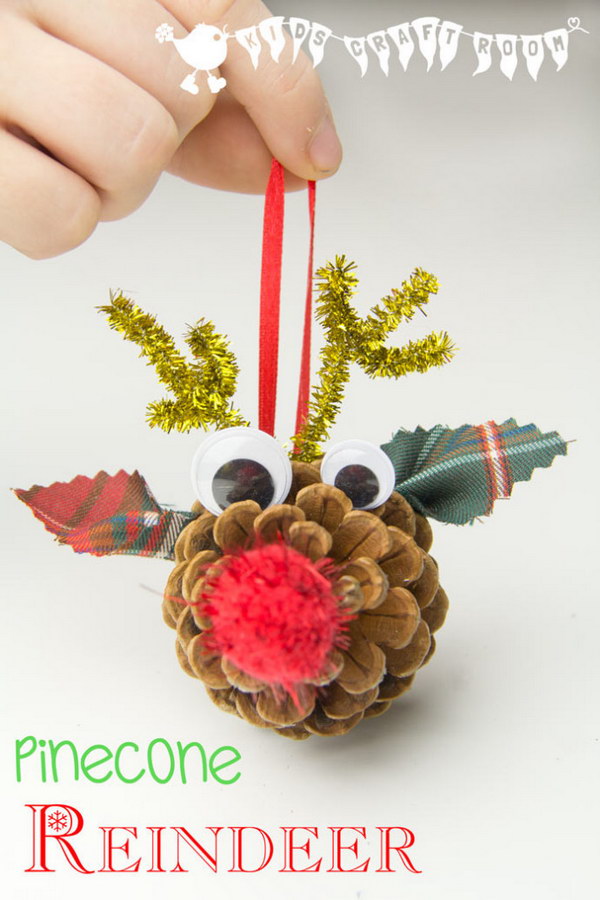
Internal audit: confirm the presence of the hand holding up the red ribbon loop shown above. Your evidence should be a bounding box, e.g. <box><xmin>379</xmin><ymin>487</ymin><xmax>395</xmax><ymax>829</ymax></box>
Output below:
<box><xmin>0</xmin><ymin>0</ymin><xmax>341</xmax><ymax>259</ymax></box>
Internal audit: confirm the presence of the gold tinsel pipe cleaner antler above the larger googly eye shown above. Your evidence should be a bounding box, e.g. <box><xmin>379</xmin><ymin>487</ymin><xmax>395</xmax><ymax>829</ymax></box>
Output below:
<box><xmin>99</xmin><ymin>293</ymin><xmax>248</xmax><ymax>431</ymax></box>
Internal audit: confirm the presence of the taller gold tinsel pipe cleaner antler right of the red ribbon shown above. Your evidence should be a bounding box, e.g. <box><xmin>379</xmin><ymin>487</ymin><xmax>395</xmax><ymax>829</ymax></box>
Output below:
<box><xmin>292</xmin><ymin>256</ymin><xmax>455</xmax><ymax>462</ymax></box>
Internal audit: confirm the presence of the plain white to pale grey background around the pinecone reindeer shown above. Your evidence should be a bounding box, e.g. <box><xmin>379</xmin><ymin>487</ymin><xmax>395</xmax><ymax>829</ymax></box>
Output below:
<box><xmin>0</xmin><ymin>0</ymin><xmax>600</xmax><ymax>900</ymax></box>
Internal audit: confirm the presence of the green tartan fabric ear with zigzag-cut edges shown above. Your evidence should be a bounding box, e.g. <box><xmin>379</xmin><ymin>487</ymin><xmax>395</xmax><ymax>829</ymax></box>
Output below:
<box><xmin>382</xmin><ymin>419</ymin><xmax>567</xmax><ymax>525</ymax></box>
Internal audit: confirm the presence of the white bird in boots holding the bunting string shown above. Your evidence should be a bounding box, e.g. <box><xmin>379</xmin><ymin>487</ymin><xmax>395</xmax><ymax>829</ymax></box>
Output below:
<box><xmin>154</xmin><ymin>22</ymin><xmax>229</xmax><ymax>94</ymax></box>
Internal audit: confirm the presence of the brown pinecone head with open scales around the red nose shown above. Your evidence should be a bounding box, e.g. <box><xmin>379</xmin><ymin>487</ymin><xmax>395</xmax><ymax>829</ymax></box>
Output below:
<box><xmin>163</xmin><ymin>462</ymin><xmax>448</xmax><ymax>740</ymax></box>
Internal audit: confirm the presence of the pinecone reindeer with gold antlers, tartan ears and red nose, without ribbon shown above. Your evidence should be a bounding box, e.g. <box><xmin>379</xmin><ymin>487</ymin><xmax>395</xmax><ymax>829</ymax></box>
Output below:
<box><xmin>16</xmin><ymin>170</ymin><xmax>566</xmax><ymax>740</ymax></box>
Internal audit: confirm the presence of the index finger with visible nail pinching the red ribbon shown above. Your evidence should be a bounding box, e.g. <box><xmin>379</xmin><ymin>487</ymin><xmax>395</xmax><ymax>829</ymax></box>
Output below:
<box><xmin>163</xmin><ymin>0</ymin><xmax>342</xmax><ymax>180</ymax></box>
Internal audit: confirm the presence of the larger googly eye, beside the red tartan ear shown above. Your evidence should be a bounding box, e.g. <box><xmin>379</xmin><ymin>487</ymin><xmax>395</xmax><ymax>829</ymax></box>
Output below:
<box><xmin>192</xmin><ymin>426</ymin><xmax>292</xmax><ymax>516</ymax></box>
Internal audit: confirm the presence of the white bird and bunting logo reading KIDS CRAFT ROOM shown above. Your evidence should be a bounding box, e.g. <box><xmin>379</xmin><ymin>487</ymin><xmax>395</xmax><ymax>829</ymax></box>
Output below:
<box><xmin>154</xmin><ymin>16</ymin><xmax>589</xmax><ymax>94</ymax></box>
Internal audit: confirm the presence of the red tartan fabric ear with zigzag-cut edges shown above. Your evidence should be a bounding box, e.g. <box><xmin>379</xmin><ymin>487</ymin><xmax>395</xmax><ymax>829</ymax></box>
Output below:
<box><xmin>15</xmin><ymin>470</ymin><xmax>194</xmax><ymax>559</ymax></box>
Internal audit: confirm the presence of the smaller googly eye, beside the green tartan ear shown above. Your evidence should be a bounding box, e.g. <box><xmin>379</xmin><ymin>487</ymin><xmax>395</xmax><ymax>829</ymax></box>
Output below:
<box><xmin>321</xmin><ymin>440</ymin><xmax>396</xmax><ymax>509</ymax></box>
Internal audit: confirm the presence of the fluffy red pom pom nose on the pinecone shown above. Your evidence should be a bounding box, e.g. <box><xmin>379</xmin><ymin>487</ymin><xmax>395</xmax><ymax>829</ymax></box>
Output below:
<box><xmin>201</xmin><ymin>542</ymin><xmax>351</xmax><ymax>694</ymax></box>
